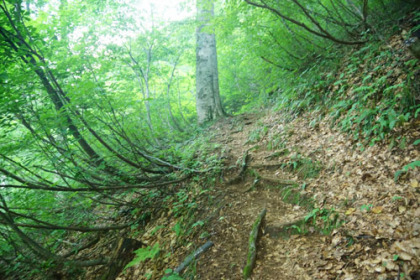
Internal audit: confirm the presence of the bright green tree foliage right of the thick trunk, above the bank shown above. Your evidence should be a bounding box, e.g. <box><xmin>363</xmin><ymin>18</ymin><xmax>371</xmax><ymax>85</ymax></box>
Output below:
<box><xmin>216</xmin><ymin>0</ymin><xmax>416</xmax><ymax>112</ymax></box>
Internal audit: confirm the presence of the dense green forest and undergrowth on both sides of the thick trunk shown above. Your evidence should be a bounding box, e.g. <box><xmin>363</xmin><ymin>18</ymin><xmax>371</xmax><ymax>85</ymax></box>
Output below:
<box><xmin>0</xmin><ymin>0</ymin><xmax>420</xmax><ymax>279</ymax></box>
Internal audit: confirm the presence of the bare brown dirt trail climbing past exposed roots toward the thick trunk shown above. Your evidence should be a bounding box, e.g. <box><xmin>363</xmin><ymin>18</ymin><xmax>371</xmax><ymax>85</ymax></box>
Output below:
<box><xmin>197</xmin><ymin>115</ymin><xmax>312</xmax><ymax>279</ymax></box>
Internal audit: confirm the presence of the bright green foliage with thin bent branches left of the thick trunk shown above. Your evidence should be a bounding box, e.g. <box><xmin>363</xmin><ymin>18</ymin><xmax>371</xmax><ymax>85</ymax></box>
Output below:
<box><xmin>0</xmin><ymin>0</ymin><xmax>201</xmax><ymax>278</ymax></box>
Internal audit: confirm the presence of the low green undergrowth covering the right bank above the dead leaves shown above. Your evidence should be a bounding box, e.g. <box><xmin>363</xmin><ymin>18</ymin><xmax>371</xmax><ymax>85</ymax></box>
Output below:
<box><xmin>275</xmin><ymin>11</ymin><xmax>420</xmax><ymax>147</ymax></box>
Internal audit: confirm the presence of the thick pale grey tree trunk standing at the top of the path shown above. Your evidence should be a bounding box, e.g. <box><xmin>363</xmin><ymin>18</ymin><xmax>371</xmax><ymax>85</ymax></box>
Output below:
<box><xmin>196</xmin><ymin>0</ymin><xmax>225</xmax><ymax>124</ymax></box>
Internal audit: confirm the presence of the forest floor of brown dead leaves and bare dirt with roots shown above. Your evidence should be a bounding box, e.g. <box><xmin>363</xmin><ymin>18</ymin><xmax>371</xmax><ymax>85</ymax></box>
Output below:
<box><xmin>118</xmin><ymin>109</ymin><xmax>420</xmax><ymax>280</ymax></box>
